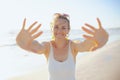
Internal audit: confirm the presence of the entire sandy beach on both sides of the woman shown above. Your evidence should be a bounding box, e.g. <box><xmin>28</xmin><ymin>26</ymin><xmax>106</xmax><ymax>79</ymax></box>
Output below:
<box><xmin>7</xmin><ymin>40</ymin><xmax>120</xmax><ymax>80</ymax></box>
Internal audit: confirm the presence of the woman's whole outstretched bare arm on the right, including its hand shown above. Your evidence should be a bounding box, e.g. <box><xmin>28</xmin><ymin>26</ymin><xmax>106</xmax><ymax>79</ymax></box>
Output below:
<box><xmin>76</xmin><ymin>18</ymin><xmax>108</xmax><ymax>52</ymax></box>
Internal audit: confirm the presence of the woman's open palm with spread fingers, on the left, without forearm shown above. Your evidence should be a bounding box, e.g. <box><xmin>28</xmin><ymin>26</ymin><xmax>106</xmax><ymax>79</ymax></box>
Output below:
<box><xmin>16</xmin><ymin>19</ymin><xmax>42</xmax><ymax>50</ymax></box>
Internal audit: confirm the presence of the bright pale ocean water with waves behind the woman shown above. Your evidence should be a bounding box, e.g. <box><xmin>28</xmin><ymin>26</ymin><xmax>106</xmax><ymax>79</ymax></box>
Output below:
<box><xmin>0</xmin><ymin>28</ymin><xmax>120</xmax><ymax>80</ymax></box>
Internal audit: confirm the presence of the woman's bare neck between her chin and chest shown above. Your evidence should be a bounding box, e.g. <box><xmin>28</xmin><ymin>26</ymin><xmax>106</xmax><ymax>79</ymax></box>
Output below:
<box><xmin>54</xmin><ymin>39</ymin><xmax>69</xmax><ymax>49</ymax></box>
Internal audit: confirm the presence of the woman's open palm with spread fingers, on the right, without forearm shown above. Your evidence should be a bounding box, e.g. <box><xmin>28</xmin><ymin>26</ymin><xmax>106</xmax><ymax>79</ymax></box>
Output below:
<box><xmin>82</xmin><ymin>18</ymin><xmax>109</xmax><ymax>50</ymax></box>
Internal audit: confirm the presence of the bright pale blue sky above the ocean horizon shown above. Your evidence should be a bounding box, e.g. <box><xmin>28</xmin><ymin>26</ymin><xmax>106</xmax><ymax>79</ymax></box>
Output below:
<box><xmin>0</xmin><ymin>0</ymin><xmax>120</xmax><ymax>33</ymax></box>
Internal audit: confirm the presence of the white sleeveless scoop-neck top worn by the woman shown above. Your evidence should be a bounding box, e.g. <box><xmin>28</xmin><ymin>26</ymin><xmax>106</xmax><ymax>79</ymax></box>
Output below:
<box><xmin>48</xmin><ymin>41</ymin><xmax>75</xmax><ymax>80</ymax></box>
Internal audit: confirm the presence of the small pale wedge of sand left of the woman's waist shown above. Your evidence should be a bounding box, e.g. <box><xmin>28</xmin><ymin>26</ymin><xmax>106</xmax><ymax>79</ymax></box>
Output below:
<box><xmin>7</xmin><ymin>65</ymin><xmax>49</xmax><ymax>80</ymax></box>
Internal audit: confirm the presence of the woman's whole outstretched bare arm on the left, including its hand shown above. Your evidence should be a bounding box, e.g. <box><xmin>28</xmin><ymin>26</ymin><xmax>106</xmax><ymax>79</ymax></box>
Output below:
<box><xmin>16</xmin><ymin>19</ymin><xmax>46</xmax><ymax>53</ymax></box>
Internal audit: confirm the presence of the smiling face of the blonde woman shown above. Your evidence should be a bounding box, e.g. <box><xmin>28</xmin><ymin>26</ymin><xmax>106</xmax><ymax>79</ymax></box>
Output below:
<box><xmin>53</xmin><ymin>18</ymin><xmax>69</xmax><ymax>39</ymax></box>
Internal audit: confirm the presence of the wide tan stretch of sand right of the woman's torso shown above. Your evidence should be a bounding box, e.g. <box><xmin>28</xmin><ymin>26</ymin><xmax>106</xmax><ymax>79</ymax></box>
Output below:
<box><xmin>76</xmin><ymin>41</ymin><xmax>120</xmax><ymax>80</ymax></box>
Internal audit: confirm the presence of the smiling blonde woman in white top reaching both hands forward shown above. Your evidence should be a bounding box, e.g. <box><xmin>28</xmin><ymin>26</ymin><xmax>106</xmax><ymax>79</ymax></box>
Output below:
<box><xmin>16</xmin><ymin>13</ymin><xmax>108</xmax><ymax>80</ymax></box>
